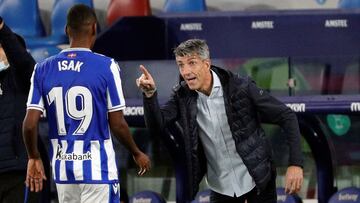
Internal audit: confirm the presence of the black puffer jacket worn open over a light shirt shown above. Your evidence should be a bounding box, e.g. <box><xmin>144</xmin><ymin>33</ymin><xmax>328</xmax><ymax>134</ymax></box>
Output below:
<box><xmin>144</xmin><ymin>66</ymin><xmax>303</xmax><ymax>197</ymax></box>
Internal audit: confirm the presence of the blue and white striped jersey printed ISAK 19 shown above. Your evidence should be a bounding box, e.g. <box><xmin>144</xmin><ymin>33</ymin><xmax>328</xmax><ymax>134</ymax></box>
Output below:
<box><xmin>27</xmin><ymin>48</ymin><xmax>125</xmax><ymax>183</ymax></box>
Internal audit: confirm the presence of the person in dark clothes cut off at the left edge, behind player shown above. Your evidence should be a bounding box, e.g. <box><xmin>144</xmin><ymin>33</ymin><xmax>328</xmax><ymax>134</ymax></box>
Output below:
<box><xmin>0</xmin><ymin>17</ymin><xmax>47</xmax><ymax>202</ymax></box>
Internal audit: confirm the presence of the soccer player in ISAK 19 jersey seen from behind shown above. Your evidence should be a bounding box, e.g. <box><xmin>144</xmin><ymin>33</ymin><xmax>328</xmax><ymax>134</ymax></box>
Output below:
<box><xmin>23</xmin><ymin>4</ymin><xmax>150</xmax><ymax>203</ymax></box>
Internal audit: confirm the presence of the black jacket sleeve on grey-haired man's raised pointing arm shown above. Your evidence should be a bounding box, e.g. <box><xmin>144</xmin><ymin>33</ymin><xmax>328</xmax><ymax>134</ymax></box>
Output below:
<box><xmin>143</xmin><ymin>92</ymin><xmax>178</xmax><ymax>134</ymax></box>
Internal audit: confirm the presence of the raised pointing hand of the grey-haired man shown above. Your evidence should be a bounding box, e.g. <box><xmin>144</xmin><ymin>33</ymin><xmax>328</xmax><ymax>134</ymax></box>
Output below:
<box><xmin>136</xmin><ymin>65</ymin><xmax>156</xmax><ymax>97</ymax></box>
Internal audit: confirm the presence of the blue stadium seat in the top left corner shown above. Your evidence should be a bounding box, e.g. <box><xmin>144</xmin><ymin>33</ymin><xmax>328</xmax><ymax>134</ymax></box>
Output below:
<box><xmin>0</xmin><ymin>0</ymin><xmax>45</xmax><ymax>38</ymax></box>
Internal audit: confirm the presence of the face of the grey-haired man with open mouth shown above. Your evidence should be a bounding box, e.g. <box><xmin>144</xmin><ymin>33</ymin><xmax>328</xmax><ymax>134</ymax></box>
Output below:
<box><xmin>176</xmin><ymin>54</ymin><xmax>212</xmax><ymax>94</ymax></box>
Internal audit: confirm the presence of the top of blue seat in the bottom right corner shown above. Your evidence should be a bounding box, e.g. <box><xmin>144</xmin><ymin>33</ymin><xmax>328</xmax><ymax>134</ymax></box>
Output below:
<box><xmin>329</xmin><ymin>187</ymin><xmax>360</xmax><ymax>203</ymax></box>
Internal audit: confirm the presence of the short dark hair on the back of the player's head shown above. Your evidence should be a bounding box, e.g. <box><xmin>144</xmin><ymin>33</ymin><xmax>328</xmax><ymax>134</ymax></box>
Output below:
<box><xmin>66</xmin><ymin>4</ymin><xmax>97</xmax><ymax>34</ymax></box>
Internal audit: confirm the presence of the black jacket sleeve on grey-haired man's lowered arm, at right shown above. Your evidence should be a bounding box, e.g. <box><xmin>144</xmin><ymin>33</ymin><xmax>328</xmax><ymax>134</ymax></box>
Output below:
<box><xmin>248</xmin><ymin>80</ymin><xmax>303</xmax><ymax>167</ymax></box>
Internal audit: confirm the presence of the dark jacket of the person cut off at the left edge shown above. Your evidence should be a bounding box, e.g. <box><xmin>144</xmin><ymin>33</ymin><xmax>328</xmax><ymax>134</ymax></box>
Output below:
<box><xmin>0</xmin><ymin>25</ymin><xmax>35</xmax><ymax>173</ymax></box>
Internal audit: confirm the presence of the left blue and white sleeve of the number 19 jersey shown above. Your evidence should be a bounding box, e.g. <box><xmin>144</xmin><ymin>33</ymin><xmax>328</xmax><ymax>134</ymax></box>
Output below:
<box><xmin>26</xmin><ymin>64</ymin><xmax>44</xmax><ymax>112</ymax></box>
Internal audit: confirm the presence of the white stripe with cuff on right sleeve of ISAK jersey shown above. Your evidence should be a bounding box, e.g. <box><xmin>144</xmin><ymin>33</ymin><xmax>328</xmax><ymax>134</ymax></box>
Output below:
<box><xmin>107</xmin><ymin>59</ymin><xmax>125</xmax><ymax>111</ymax></box>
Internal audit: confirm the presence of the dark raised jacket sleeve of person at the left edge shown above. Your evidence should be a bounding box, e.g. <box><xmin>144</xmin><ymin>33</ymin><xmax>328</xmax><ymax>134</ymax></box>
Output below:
<box><xmin>0</xmin><ymin>24</ymin><xmax>35</xmax><ymax>92</ymax></box>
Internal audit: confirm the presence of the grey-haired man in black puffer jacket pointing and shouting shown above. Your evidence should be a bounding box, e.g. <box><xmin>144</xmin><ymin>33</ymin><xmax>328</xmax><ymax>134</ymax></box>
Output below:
<box><xmin>136</xmin><ymin>39</ymin><xmax>303</xmax><ymax>203</ymax></box>
